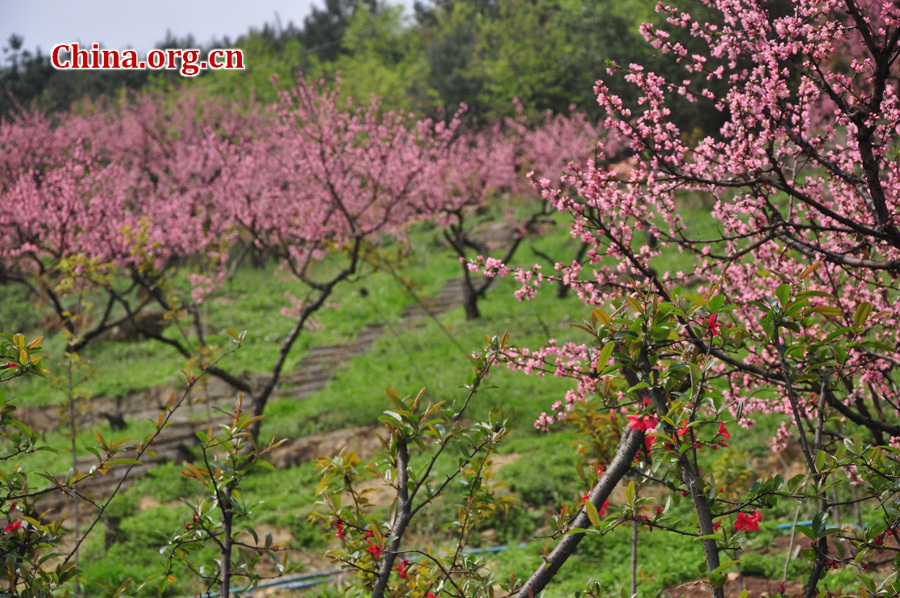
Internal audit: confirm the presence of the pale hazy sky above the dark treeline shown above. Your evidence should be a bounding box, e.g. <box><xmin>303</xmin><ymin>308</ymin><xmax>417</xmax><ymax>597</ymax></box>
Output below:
<box><xmin>0</xmin><ymin>0</ymin><xmax>412</xmax><ymax>60</ymax></box>
